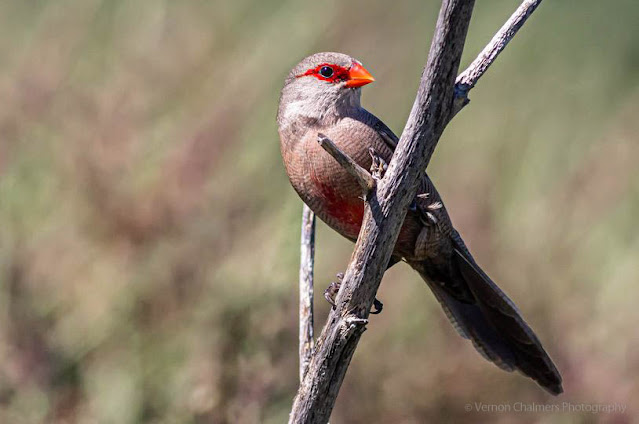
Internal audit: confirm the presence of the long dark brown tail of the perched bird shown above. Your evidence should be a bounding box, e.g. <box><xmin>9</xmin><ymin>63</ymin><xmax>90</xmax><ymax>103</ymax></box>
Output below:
<box><xmin>411</xmin><ymin>247</ymin><xmax>563</xmax><ymax>395</ymax></box>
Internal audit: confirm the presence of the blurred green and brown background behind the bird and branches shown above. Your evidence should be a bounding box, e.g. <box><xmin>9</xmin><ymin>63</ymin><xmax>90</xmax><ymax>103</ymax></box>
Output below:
<box><xmin>0</xmin><ymin>0</ymin><xmax>639</xmax><ymax>423</ymax></box>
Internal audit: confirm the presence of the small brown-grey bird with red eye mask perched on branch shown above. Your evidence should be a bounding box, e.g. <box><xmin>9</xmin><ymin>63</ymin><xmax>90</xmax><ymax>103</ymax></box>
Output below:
<box><xmin>277</xmin><ymin>52</ymin><xmax>563</xmax><ymax>395</ymax></box>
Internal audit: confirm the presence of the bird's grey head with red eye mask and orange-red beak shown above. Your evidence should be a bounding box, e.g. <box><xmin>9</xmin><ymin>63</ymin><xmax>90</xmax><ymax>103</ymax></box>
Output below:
<box><xmin>279</xmin><ymin>52</ymin><xmax>375</xmax><ymax>121</ymax></box>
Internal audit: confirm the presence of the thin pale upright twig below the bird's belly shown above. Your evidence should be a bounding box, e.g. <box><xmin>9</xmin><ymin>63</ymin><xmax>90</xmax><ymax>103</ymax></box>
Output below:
<box><xmin>299</xmin><ymin>205</ymin><xmax>315</xmax><ymax>382</ymax></box>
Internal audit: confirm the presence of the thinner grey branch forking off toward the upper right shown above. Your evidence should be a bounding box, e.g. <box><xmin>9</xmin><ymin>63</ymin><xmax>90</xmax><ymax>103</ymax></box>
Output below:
<box><xmin>455</xmin><ymin>0</ymin><xmax>541</xmax><ymax>113</ymax></box>
